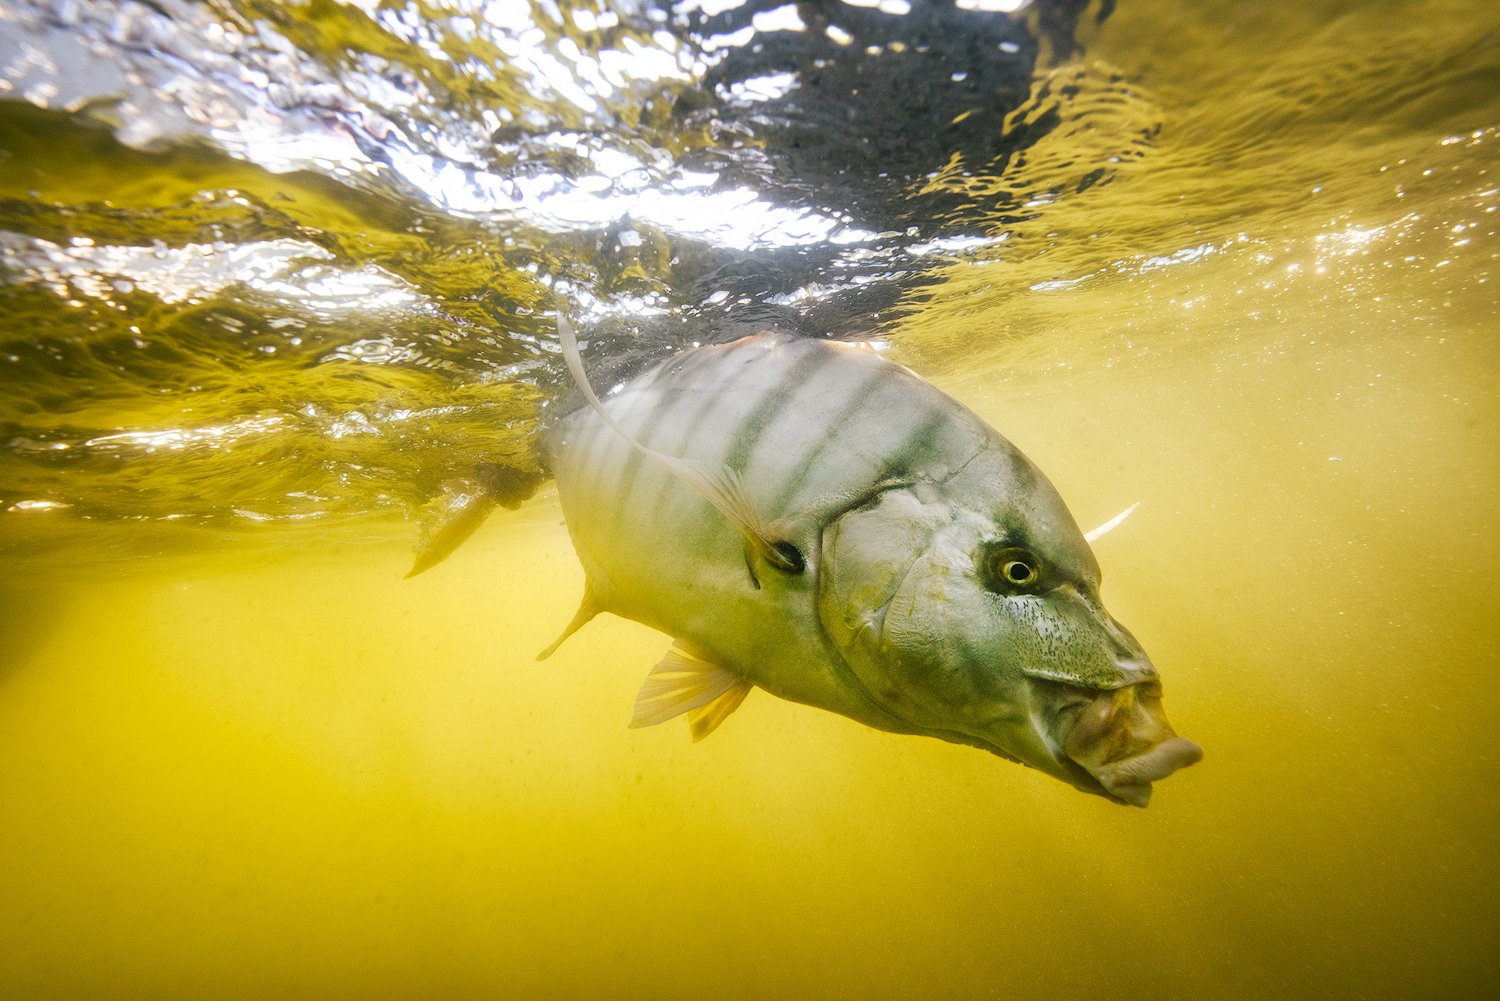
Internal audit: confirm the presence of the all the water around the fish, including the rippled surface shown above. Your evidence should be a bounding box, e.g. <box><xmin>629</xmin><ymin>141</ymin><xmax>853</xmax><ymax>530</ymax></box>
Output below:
<box><xmin>0</xmin><ymin>0</ymin><xmax>1500</xmax><ymax>999</ymax></box>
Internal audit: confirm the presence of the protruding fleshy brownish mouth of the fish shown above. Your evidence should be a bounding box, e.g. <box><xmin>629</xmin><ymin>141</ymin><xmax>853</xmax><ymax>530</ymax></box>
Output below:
<box><xmin>1064</xmin><ymin>683</ymin><xmax>1203</xmax><ymax>806</ymax></box>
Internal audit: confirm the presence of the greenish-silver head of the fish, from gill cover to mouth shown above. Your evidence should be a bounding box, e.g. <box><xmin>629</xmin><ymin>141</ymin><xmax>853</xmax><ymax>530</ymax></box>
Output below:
<box><xmin>819</xmin><ymin>444</ymin><xmax>1202</xmax><ymax>806</ymax></box>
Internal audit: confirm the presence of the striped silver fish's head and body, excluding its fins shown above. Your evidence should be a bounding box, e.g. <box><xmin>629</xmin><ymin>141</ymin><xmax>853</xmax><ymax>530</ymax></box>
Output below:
<box><xmin>543</xmin><ymin>335</ymin><xmax>1202</xmax><ymax>806</ymax></box>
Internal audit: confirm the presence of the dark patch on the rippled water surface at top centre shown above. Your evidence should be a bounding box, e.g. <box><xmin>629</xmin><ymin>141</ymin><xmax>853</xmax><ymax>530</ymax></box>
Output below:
<box><xmin>678</xmin><ymin>0</ymin><xmax>1038</xmax><ymax>226</ymax></box>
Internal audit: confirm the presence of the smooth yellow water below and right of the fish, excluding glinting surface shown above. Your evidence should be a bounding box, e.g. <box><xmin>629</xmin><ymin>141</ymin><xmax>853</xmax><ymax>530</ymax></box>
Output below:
<box><xmin>0</xmin><ymin>2</ymin><xmax>1500</xmax><ymax>1001</ymax></box>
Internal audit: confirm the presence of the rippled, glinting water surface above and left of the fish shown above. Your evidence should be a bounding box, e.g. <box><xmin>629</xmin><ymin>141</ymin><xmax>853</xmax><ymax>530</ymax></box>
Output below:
<box><xmin>0</xmin><ymin>0</ymin><xmax>1109</xmax><ymax>543</ymax></box>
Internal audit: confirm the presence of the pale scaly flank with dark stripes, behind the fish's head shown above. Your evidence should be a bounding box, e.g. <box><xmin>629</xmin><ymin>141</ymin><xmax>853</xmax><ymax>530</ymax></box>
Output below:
<box><xmin>549</xmin><ymin>336</ymin><xmax>984</xmax><ymax>720</ymax></box>
